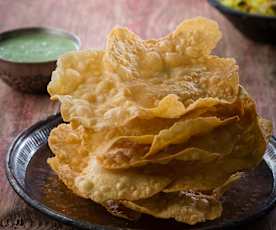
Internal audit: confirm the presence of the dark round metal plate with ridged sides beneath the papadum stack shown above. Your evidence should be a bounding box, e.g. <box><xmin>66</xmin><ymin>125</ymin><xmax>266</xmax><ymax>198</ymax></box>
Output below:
<box><xmin>6</xmin><ymin>115</ymin><xmax>276</xmax><ymax>230</ymax></box>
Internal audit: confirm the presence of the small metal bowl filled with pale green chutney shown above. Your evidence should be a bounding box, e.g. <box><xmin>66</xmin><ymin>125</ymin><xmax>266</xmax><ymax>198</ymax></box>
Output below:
<box><xmin>0</xmin><ymin>27</ymin><xmax>80</xmax><ymax>94</ymax></box>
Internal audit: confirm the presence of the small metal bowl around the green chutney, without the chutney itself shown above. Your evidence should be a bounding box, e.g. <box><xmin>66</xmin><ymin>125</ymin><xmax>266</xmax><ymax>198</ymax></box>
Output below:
<box><xmin>0</xmin><ymin>27</ymin><xmax>80</xmax><ymax>94</ymax></box>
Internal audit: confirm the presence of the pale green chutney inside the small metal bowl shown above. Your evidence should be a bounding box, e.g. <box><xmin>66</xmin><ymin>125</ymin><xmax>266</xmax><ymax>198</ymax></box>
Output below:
<box><xmin>0</xmin><ymin>31</ymin><xmax>78</xmax><ymax>63</ymax></box>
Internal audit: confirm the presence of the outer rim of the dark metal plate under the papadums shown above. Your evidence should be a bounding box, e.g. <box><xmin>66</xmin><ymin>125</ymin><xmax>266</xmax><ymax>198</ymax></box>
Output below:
<box><xmin>5</xmin><ymin>113</ymin><xmax>276</xmax><ymax>230</ymax></box>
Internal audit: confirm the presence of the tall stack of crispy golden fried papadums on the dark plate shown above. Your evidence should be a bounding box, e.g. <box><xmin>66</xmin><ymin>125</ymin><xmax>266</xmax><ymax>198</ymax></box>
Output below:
<box><xmin>48</xmin><ymin>17</ymin><xmax>272</xmax><ymax>224</ymax></box>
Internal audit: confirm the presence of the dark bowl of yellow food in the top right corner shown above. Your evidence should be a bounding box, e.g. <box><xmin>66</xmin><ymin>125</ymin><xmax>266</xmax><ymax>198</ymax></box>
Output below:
<box><xmin>208</xmin><ymin>0</ymin><xmax>276</xmax><ymax>44</ymax></box>
